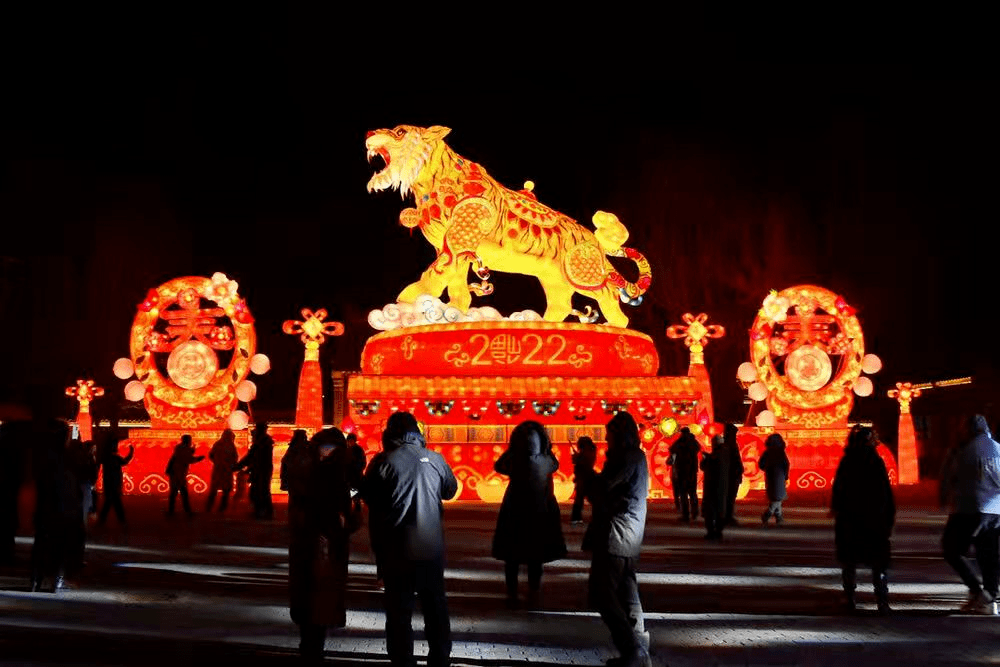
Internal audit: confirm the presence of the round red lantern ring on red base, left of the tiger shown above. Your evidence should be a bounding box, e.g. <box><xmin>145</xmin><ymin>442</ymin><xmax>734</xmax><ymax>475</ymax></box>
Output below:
<box><xmin>114</xmin><ymin>273</ymin><xmax>276</xmax><ymax>494</ymax></box>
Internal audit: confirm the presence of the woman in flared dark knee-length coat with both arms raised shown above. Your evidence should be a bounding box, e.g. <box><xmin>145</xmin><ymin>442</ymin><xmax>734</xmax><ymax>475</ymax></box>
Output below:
<box><xmin>492</xmin><ymin>421</ymin><xmax>566</xmax><ymax>609</ymax></box>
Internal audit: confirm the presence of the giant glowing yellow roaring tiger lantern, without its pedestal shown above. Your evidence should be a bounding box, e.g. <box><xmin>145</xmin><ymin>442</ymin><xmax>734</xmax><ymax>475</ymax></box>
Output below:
<box><xmin>365</xmin><ymin>125</ymin><xmax>651</xmax><ymax>327</ymax></box>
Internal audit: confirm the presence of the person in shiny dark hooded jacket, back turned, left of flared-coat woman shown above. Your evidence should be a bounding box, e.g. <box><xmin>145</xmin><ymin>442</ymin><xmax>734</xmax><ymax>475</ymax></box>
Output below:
<box><xmin>361</xmin><ymin>412</ymin><xmax>458</xmax><ymax>667</ymax></box>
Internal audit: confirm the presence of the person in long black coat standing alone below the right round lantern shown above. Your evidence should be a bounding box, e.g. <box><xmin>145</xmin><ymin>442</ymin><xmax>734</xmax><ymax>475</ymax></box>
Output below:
<box><xmin>831</xmin><ymin>427</ymin><xmax>896</xmax><ymax>613</ymax></box>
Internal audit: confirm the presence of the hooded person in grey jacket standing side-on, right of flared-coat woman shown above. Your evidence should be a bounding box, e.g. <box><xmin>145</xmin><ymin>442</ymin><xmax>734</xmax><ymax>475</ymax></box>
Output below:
<box><xmin>583</xmin><ymin>412</ymin><xmax>652</xmax><ymax>667</ymax></box>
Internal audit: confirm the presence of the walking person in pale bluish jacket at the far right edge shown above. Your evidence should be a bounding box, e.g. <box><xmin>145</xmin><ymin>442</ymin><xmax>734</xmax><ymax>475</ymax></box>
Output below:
<box><xmin>941</xmin><ymin>414</ymin><xmax>1000</xmax><ymax>616</ymax></box>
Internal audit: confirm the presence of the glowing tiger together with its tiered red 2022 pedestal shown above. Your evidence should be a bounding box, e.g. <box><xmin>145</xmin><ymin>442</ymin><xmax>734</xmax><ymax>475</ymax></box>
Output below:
<box><xmin>347</xmin><ymin>125</ymin><xmax>716</xmax><ymax>502</ymax></box>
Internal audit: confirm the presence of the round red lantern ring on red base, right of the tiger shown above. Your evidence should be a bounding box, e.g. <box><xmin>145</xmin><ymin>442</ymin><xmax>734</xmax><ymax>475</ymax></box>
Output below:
<box><xmin>738</xmin><ymin>285</ymin><xmax>897</xmax><ymax>489</ymax></box>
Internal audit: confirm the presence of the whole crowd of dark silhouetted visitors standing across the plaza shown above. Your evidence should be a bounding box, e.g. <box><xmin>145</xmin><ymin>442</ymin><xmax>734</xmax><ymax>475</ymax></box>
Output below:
<box><xmin>0</xmin><ymin>412</ymin><xmax>1000</xmax><ymax>666</ymax></box>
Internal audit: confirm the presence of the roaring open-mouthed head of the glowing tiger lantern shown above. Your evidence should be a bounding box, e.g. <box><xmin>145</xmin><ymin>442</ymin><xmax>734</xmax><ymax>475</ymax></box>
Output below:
<box><xmin>365</xmin><ymin>125</ymin><xmax>451</xmax><ymax>198</ymax></box>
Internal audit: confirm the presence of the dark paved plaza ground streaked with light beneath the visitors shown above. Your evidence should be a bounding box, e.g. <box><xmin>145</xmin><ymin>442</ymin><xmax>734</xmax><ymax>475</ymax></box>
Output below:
<box><xmin>0</xmin><ymin>491</ymin><xmax>1000</xmax><ymax>667</ymax></box>
